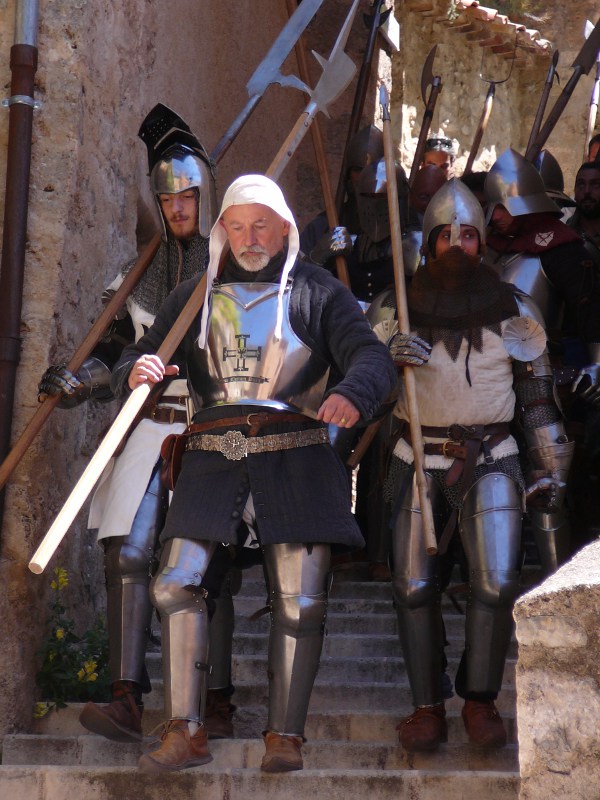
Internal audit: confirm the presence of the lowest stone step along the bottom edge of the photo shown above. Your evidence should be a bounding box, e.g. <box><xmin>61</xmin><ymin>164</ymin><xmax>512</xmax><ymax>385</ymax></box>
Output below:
<box><xmin>0</xmin><ymin>763</ymin><xmax>519</xmax><ymax>800</ymax></box>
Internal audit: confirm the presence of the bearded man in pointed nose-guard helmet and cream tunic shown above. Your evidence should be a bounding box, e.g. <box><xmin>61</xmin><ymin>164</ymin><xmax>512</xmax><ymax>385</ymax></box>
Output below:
<box><xmin>376</xmin><ymin>179</ymin><xmax>572</xmax><ymax>751</ymax></box>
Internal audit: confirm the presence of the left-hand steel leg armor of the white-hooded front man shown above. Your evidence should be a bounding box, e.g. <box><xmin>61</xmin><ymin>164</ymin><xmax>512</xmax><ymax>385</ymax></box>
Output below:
<box><xmin>150</xmin><ymin>539</ymin><xmax>217</xmax><ymax>723</ymax></box>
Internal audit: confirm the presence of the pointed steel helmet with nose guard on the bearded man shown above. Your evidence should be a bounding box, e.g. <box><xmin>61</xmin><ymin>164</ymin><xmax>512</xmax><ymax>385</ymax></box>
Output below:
<box><xmin>423</xmin><ymin>178</ymin><xmax>485</xmax><ymax>249</ymax></box>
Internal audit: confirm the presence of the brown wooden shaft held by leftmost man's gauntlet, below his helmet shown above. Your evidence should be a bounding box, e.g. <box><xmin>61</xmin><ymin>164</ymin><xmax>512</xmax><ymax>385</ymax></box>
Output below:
<box><xmin>0</xmin><ymin>233</ymin><xmax>160</xmax><ymax>489</ymax></box>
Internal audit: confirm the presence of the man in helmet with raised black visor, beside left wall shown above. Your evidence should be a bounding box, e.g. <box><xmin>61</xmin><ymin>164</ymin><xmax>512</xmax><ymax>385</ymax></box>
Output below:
<box><xmin>39</xmin><ymin>105</ymin><xmax>223</xmax><ymax>741</ymax></box>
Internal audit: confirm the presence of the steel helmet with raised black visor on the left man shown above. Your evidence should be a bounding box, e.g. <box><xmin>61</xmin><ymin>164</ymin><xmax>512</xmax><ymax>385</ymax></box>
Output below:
<box><xmin>138</xmin><ymin>103</ymin><xmax>217</xmax><ymax>239</ymax></box>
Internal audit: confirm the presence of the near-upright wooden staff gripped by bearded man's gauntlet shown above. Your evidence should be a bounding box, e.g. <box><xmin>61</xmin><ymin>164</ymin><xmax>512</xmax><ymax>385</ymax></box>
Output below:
<box><xmin>379</xmin><ymin>84</ymin><xmax>437</xmax><ymax>555</ymax></box>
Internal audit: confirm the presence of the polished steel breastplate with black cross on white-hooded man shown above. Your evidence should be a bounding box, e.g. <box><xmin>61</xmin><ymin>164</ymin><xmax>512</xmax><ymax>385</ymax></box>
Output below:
<box><xmin>188</xmin><ymin>282</ymin><xmax>329</xmax><ymax>418</ymax></box>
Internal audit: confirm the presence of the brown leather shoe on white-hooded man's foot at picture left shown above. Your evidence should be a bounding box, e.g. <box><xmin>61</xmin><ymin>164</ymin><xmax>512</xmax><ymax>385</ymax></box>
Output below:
<box><xmin>138</xmin><ymin>719</ymin><xmax>212</xmax><ymax>772</ymax></box>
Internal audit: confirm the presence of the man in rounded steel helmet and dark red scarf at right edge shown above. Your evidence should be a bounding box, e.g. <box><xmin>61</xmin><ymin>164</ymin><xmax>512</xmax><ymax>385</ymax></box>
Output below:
<box><xmin>485</xmin><ymin>149</ymin><xmax>600</xmax><ymax>573</ymax></box>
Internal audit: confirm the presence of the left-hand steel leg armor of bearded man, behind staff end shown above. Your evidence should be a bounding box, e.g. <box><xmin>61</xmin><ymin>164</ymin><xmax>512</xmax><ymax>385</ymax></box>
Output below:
<box><xmin>392</xmin><ymin>471</ymin><xmax>449</xmax><ymax>706</ymax></box>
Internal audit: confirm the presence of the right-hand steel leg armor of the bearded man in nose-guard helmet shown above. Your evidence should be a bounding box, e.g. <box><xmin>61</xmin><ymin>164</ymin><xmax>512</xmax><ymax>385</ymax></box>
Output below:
<box><xmin>457</xmin><ymin>473</ymin><xmax>521</xmax><ymax>697</ymax></box>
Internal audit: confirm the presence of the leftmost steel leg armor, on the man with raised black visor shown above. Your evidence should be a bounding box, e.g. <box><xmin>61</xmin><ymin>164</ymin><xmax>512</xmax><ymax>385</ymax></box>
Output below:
<box><xmin>104</xmin><ymin>471</ymin><xmax>166</xmax><ymax>684</ymax></box>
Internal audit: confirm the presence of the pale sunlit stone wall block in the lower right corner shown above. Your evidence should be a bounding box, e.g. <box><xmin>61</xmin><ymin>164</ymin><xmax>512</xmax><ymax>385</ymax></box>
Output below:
<box><xmin>515</xmin><ymin>542</ymin><xmax>600</xmax><ymax>800</ymax></box>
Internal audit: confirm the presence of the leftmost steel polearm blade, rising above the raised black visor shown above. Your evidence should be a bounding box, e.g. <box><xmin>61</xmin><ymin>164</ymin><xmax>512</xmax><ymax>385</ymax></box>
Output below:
<box><xmin>210</xmin><ymin>0</ymin><xmax>323</xmax><ymax>163</ymax></box>
